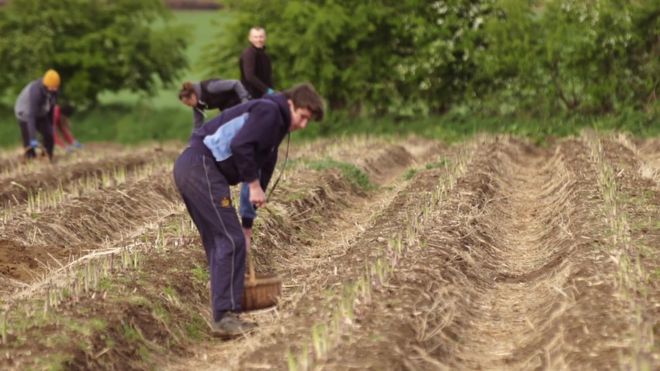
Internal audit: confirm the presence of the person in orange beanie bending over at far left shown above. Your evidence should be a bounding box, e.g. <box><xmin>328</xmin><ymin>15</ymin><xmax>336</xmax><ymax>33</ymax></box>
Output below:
<box><xmin>14</xmin><ymin>69</ymin><xmax>61</xmax><ymax>160</ymax></box>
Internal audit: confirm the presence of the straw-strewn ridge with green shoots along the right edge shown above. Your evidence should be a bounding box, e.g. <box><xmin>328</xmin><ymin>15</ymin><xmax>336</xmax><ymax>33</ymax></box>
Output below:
<box><xmin>584</xmin><ymin>132</ymin><xmax>660</xmax><ymax>369</ymax></box>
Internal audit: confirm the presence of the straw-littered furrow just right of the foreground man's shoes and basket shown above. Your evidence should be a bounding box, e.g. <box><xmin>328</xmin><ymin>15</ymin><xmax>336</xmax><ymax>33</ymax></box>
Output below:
<box><xmin>169</xmin><ymin>138</ymin><xmax>468</xmax><ymax>369</ymax></box>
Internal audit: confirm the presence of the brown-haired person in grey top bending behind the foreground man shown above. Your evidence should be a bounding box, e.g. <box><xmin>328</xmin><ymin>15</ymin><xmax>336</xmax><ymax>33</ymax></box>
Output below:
<box><xmin>179</xmin><ymin>79</ymin><xmax>250</xmax><ymax>129</ymax></box>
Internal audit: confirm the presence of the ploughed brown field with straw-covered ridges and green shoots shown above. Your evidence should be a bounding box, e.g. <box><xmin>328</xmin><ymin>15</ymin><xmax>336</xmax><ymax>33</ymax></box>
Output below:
<box><xmin>0</xmin><ymin>132</ymin><xmax>660</xmax><ymax>370</ymax></box>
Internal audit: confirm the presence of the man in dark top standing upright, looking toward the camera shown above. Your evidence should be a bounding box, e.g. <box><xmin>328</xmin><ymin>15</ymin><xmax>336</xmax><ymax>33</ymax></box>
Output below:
<box><xmin>239</xmin><ymin>27</ymin><xmax>274</xmax><ymax>98</ymax></box>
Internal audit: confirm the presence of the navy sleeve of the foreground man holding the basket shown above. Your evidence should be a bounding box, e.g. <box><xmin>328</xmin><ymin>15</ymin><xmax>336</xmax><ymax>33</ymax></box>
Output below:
<box><xmin>231</xmin><ymin>101</ymin><xmax>282</xmax><ymax>183</ymax></box>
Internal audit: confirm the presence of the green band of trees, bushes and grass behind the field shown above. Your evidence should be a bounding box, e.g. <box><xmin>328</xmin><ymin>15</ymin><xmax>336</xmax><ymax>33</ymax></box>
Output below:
<box><xmin>0</xmin><ymin>0</ymin><xmax>660</xmax><ymax>150</ymax></box>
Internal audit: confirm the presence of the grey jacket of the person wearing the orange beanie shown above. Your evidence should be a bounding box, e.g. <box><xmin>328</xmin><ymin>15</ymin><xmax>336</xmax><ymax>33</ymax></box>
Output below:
<box><xmin>14</xmin><ymin>79</ymin><xmax>57</xmax><ymax>140</ymax></box>
